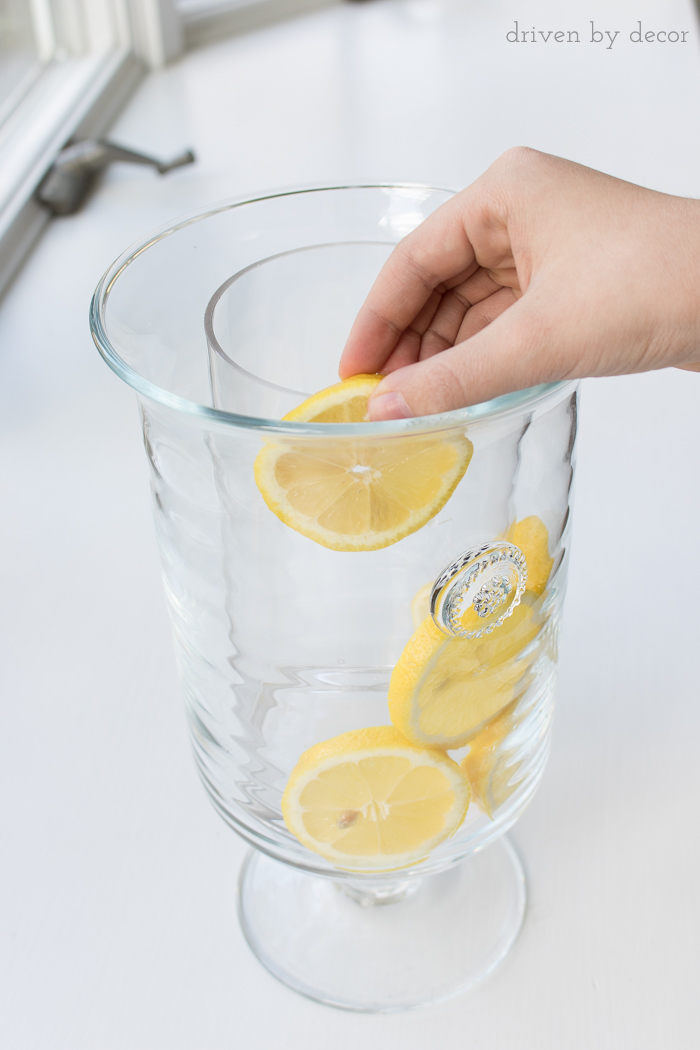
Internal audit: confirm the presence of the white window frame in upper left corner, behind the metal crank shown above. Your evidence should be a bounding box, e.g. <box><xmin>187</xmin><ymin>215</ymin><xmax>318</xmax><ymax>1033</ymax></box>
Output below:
<box><xmin>0</xmin><ymin>0</ymin><xmax>342</xmax><ymax>295</ymax></box>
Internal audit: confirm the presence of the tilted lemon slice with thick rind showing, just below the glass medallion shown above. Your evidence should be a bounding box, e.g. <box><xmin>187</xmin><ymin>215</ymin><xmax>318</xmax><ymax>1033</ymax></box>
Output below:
<box><xmin>389</xmin><ymin>609</ymin><xmax>528</xmax><ymax>751</ymax></box>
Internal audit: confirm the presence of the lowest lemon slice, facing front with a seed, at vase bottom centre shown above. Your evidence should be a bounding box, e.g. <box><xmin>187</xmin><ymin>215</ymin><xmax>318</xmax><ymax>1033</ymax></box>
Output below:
<box><xmin>282</xmin><ymin>726</ymin><xmax>470</xmax><ymax>872</ymax></box>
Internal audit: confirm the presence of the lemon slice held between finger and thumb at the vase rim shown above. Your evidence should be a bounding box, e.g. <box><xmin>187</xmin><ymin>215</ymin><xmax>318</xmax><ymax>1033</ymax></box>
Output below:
<box><xmin>254</xmin><ymin>376</ymin><xmax>472</xmax><ymax>550</ymax></box>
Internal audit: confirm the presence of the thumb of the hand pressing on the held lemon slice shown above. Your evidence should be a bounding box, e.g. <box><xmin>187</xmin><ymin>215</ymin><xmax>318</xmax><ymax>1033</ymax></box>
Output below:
<box><xmin>368</xmin><ymin>297</ymin><xmax>571</xmax><ymax>420</ymax></box>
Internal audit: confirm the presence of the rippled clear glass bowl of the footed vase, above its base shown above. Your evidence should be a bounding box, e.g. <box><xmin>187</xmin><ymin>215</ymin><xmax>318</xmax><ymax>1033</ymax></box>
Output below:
<box><xmin>92</xmin><ymin>187</ymin><xmax>577</xmax><ymax>882</ymax></box>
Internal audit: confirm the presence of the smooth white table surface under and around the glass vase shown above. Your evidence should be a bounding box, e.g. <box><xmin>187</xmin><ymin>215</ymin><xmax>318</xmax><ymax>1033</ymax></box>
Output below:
<box><xmin>0</xmin><ymin>0</ymin><xmax>700</xmax><ymax>1050</ymax></box>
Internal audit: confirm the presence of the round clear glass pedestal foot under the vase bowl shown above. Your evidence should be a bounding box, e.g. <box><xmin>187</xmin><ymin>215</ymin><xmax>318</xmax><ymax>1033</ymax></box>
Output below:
<box><xmin>239</xmin><ymin>839</ymin><xmax>526</xmax><ymax>1013</ymax></box>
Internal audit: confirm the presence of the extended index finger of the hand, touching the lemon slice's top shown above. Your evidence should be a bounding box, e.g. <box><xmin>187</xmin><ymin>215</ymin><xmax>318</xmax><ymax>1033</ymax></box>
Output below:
<box><xmin>338</xmin><ymin>194</ymin><xmax>479</xmax><ymax>378</ymax></box>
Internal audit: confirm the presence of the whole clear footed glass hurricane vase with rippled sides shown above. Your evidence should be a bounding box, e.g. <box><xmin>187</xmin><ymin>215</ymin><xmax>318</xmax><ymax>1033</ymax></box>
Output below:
<box><xmin>91</xmin><ymin>186</ymin><xmax>576</xmax><ymax>1010</ymax></box>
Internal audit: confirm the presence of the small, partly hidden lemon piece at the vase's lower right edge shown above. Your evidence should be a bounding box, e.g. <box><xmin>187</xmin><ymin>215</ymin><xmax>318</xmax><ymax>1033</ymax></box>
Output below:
<box><xmin>462</xmin><ymin>704</ymin><xmax>519</xmax><ymax>819</ymax></box>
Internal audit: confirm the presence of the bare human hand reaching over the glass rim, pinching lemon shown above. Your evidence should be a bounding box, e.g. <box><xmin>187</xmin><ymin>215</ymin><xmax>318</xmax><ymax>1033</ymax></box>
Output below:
<box><xmin>339</xmin><ymin>148</ymin><xmax>700</xmax><ymax>419</ymax></box>
